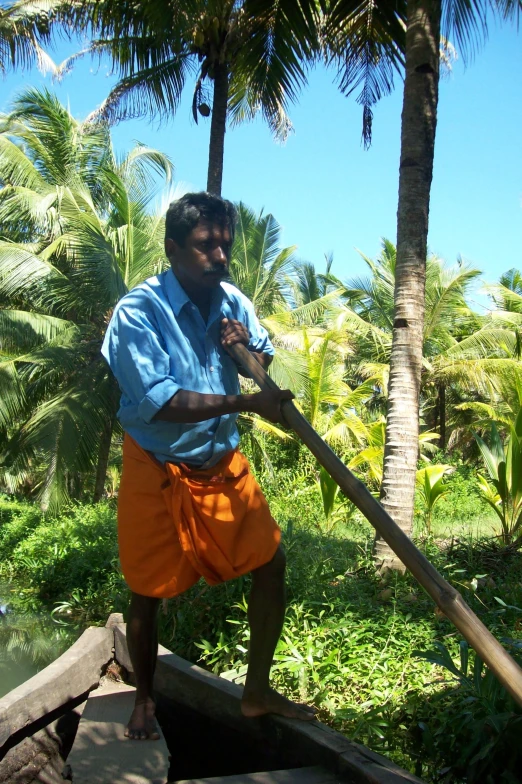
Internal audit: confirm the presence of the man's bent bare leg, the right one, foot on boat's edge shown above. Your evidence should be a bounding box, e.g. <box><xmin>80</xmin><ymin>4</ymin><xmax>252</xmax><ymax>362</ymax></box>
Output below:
<box><xmin>241</xmin><ymin>548</ymin><xmax>315</xmax><ymax>721</ymax></box>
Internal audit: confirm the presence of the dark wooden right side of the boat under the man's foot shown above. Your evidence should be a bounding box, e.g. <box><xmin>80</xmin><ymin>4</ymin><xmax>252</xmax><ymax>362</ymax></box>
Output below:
<box><xmin>114</xmin><ymin>624</ymin><xmax>423</xmax><ymax>784</ymax></box>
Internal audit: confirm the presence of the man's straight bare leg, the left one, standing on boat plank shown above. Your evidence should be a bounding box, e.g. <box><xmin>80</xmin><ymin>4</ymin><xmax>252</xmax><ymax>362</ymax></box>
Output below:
<box><xmin>125</xmin><ymin>593</ymin><xmax>160</xmax><ymax>740</ymax></box>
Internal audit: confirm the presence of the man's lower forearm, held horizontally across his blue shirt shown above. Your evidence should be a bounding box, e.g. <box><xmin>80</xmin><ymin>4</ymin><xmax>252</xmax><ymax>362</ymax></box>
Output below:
<box><xmin>154</xmin><ymin>389</ymin><xmax>254</xmax><ymax>424</ymax></box>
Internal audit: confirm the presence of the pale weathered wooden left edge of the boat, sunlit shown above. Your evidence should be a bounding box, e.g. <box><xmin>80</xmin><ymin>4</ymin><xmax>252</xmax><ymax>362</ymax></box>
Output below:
<box><xmin>0</xmin><ymin>626</ymin><xmax>114</xmax><ymax>746</ymax></box>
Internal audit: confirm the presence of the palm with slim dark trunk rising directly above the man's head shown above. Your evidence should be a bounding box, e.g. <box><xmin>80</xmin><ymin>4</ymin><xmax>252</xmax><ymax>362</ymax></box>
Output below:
<box><xmin>35</xmin><ymin>0</ymin><xmax>319</xmax><ymax>194</ymax></box>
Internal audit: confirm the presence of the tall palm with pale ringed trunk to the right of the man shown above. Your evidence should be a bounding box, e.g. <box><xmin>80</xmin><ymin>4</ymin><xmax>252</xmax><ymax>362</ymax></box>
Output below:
<box><xmin>327</xmin><ymin>0</ymin><xmax>520</xmax><ymax>568</ymax></box>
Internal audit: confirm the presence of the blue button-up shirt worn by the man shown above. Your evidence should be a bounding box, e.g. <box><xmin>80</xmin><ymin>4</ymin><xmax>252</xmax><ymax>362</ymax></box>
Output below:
<box><xmin>102</xmin><ymin>269</ymin><xmax>274</xmax><ymax>467</ymax></box>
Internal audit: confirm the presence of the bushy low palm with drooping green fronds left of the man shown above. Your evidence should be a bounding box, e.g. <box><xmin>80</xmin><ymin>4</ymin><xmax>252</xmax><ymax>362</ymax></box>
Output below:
<box><xmin>0</xmin><ymin>90</ymin><xmax>171</xmax><ymax>510</ymax></box>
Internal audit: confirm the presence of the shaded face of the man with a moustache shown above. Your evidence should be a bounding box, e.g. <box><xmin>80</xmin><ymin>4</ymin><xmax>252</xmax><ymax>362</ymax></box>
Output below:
<box><xmin>165</xmin><ymin>221</ymin><xmax>232</xmax><ymax>294</ymax></box>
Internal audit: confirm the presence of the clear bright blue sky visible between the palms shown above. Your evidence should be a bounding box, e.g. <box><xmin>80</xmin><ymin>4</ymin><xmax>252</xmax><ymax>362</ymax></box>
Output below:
<box><xmin>0</xmin><ymin>26</ymin><xmax>522</xmax><ymax>302</ymax></box>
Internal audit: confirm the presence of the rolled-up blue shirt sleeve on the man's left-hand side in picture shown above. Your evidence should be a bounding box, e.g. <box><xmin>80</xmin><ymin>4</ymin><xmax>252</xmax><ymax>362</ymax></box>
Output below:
<box><xmin>102</xmin><ymin>306</ymin><xmax>181</xmax><ymax>424</ymax></box>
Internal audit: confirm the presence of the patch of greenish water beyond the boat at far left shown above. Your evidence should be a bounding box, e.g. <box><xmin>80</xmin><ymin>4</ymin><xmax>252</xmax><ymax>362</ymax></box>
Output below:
<box><xmin>0</xmin><ymin>583</ymin><xmax>82</xmax><ymax>698</ymax></box>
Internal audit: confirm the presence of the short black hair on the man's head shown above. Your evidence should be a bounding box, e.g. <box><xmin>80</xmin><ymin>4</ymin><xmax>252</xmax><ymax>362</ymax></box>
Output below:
<box><xmin>165</xmin><ymin>191</ymin><xmax>237</xmax><ymax>248</ymax></box>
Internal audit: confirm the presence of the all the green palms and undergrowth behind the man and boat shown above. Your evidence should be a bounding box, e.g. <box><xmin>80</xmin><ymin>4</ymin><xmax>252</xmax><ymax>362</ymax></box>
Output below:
<box><xmin>0</xmin><ymin>0</ymin><xmax>522</xmax><ymax>784</ymax></box>
